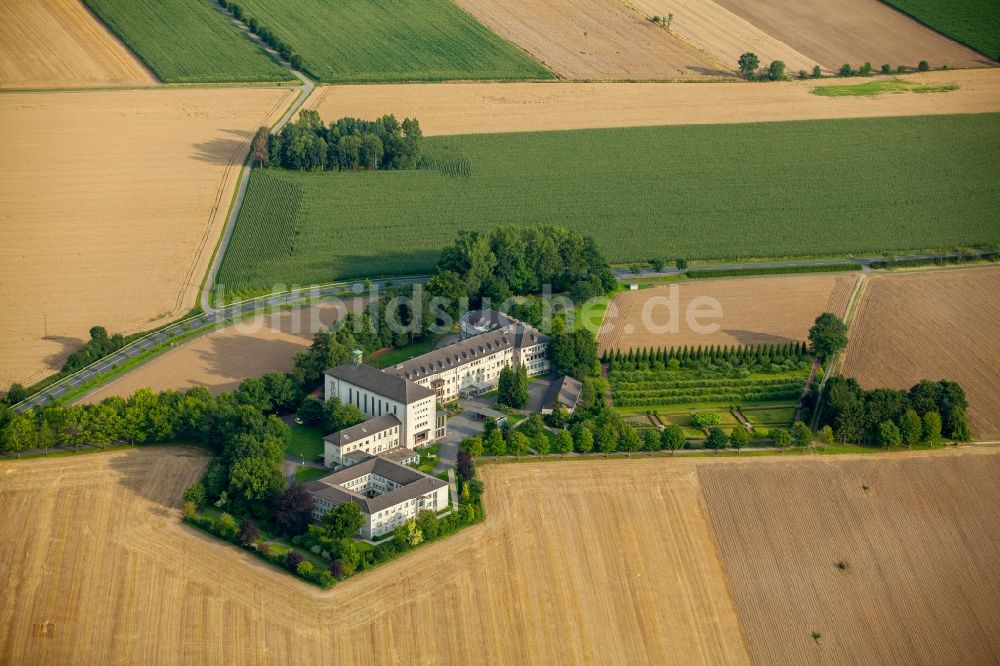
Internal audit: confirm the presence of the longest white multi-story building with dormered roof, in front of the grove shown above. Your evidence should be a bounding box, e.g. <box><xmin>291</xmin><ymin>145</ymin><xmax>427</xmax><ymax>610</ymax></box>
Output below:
<box><xmin>386</xmin><ymin>311</ymin><xmax>549</xmax><ymax>402</ymax></box>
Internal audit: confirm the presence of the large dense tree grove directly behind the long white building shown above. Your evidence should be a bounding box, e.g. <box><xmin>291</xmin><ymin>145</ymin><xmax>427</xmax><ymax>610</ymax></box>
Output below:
<box><xmin>437</xmin><ymin>226</ymin><xmax>615</xmax><ymax>305</ymax></box>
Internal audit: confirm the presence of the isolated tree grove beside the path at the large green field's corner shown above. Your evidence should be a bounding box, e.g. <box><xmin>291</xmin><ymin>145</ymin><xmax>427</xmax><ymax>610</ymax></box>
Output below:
<box><xmin>269</xmin><ymin>109</ymin><xmax>423</xmax><ymax>171</ymax></box>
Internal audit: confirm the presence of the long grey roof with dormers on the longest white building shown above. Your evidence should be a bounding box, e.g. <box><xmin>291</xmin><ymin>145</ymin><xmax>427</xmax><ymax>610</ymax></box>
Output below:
<box><xmin>386</xmin><ymin>322</ymin><xmax>549</xmax><ymax>380</ymax></box>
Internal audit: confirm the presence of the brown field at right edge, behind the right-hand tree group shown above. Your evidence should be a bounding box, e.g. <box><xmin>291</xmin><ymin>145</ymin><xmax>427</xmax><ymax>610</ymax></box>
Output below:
<box><xmin>842</xmin><ymin>267</ymin><xmax>1000</xmax><ymax>440</ymax></box>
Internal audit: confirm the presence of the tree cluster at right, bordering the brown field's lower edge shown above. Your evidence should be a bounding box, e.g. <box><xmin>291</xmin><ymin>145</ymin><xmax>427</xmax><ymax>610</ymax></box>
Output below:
<box><xmin>821</xmin><ymin>376</ymin><xmax>971</xmax><ymax>447</ymax></box>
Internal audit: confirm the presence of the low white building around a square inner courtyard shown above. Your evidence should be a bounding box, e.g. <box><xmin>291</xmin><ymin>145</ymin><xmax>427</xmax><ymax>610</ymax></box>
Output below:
<box><xmin>304</xmin><ymin>457</ymin><xmax>448</xmax><ymax>539</ymax></box>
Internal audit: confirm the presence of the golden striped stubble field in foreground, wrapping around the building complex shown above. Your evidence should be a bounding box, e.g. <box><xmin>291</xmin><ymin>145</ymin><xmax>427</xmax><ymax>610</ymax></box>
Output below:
<box><xmin>0</xmin><ymin>448</ymin><xmax>747</xmax><ymax>665</ymax></box>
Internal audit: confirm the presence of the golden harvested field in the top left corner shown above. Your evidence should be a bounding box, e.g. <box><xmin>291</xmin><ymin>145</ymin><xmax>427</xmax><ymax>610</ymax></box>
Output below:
<box><xmin>0</xmin><ymin>0</ymin><xmax>156</xmax><ymax>88</ymax></box>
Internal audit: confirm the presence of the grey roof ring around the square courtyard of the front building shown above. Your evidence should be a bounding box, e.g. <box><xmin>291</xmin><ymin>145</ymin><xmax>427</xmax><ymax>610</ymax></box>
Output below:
<box><xmin>303</xmin><ymin>457</ymin><xmax>448</xmax><ymax>515</ymax></box>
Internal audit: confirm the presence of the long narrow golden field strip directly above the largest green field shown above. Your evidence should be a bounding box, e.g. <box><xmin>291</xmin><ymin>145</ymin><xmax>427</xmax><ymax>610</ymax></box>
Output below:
<box><xmin>314</xmin><ymin>68</ymin><xmax>1000</xmax><ymax>136</ymax></box>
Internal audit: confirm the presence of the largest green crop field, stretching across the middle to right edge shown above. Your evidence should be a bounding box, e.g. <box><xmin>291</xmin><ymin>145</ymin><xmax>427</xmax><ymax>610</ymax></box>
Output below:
<box><xmin>219</xmin><ymin>114</ymin><xmax>1000</xmax><ymax>292</ymax></box>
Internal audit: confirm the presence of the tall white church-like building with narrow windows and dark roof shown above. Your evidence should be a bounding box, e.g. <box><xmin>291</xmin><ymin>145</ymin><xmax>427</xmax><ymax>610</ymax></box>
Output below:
<box><xmin>324</xmin><ymin>358</ymin><xmax>444</xmax><ymax>449</ymax></box>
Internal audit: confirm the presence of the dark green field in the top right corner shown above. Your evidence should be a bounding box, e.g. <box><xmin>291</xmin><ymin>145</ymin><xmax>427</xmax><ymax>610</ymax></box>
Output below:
<box><xmin>885</xmin><ymin>0</ymin><xmax>1000</xmax><ymax>60</ymax></box>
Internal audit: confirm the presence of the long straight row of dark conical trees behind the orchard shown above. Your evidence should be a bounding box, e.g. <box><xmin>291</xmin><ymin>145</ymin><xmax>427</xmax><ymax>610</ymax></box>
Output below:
<box><xmin>601</xmin><ymin>342</ymin><xmax>809</xmax><ymax>372</ymax></box>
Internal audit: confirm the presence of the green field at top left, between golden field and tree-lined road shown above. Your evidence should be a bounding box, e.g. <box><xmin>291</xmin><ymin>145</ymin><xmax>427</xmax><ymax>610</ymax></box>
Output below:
<box><xmin>84</xmin><ymin>0</ymin><xmax>293</xmax><ymax>83</ymax></box>
